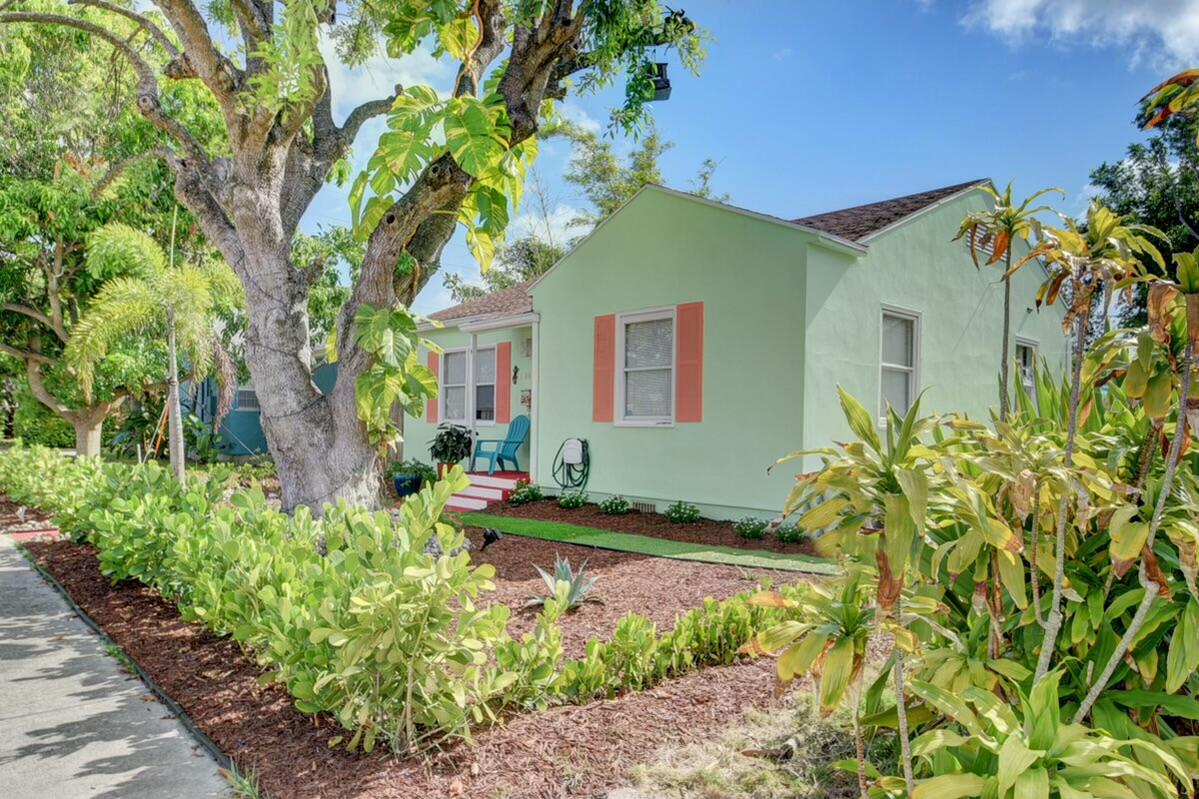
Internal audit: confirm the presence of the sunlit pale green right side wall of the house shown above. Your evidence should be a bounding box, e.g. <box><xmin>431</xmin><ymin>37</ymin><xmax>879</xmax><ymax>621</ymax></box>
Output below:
<box><xmin>803</xmin><ymin>192</ymin><xmax>1068</xmax><ymax>469</ymax></box>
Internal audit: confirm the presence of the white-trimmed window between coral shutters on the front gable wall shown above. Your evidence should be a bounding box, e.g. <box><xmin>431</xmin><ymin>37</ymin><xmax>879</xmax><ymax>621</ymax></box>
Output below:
<box><xmin>616</xmin><ymin>308</ymin><xmax>675</xmax><ymax>425</ymax></box>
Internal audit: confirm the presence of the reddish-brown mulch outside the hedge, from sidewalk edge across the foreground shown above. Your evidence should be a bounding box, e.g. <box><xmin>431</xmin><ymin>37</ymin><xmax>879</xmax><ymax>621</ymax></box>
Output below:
<box><xmin>28</xmin><ymin>539</ymin><xmax>773</xmax><ymax>799</ymax></box>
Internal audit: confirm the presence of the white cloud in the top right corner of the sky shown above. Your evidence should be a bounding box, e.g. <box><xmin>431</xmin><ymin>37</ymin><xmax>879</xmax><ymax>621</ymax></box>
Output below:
<box><xmin>964</xmin><ymin>0</ymin><xmax>1199</xmax><ymax>66</ymax></box>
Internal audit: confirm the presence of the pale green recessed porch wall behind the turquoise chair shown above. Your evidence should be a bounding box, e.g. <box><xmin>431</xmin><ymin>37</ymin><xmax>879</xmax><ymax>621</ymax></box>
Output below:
<box><xmin>404</xmin><ymin>326</ymin><xmax>532</xmax><ymax>471</ymax></box>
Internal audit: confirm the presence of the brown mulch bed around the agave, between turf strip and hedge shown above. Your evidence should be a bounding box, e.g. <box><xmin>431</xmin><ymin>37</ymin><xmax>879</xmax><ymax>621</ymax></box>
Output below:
<box><xmin>468</xmin><ymin>528</ymin><xmax>802</xmax><ymax>657</ymax></box>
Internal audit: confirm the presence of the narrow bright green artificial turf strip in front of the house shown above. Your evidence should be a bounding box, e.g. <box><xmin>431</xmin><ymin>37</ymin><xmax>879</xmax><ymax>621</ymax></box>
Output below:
<box><xmin>458</xmin><ymin>512</ymin><xmax>838</xmax><ymax>575</ymax></box>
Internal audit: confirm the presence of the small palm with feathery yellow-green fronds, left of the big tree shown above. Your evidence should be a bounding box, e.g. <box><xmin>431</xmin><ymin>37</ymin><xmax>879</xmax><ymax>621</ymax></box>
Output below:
<box><xmin>66</xmin><ymin>214</ymin><xmax>242</xmax><ymax>482</ymax></box>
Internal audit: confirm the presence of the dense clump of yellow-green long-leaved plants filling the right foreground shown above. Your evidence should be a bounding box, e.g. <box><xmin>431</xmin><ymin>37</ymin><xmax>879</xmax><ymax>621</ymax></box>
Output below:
<box><xmin>749</xmin><ymin>205</ymin><xmax>1199</xmax><ymax>799</ymax></box>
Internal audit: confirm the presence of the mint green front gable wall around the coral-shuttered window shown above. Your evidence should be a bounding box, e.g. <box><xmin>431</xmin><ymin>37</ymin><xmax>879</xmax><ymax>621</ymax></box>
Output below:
<box><xmin>532</xmin><ymin>191</ymin><xmax>812</xmax><ymax>517</ymax></box>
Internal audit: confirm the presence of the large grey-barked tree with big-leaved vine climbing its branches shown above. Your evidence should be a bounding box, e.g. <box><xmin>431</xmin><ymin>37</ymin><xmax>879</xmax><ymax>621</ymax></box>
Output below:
<box><xmin>0</xmin><ymin>0</ymin><xmax>703</xmax><ymax>512</ymax></box>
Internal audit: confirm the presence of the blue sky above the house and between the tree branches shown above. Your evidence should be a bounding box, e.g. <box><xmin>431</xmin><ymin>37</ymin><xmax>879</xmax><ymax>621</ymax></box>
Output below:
<box><xmin>305</xmin><ymin>0</ymin><xmax>1199</xmax><ymax>313</ymax></box>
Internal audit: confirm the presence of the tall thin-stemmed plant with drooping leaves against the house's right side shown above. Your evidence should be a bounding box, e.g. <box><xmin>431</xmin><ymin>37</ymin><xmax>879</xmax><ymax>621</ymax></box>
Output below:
<box><xmin>953</xmin><ymin>184</ymin><xmax>1065</xmax><ymax>419</ymax></box>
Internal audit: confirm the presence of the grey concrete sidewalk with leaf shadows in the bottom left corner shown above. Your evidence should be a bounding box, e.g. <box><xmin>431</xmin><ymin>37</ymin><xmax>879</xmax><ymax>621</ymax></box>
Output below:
<box><xmin>0</xmin><ymin>535</ymin><xmax>229</xmax><ymax>799</ymax></box>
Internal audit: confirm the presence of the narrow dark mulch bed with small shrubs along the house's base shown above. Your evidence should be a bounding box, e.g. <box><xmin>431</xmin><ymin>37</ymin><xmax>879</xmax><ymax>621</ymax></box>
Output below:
<box><xmin>483</xmin><ymin>499</ymin><xmax>815</xmax><ymax>554</ymax></box>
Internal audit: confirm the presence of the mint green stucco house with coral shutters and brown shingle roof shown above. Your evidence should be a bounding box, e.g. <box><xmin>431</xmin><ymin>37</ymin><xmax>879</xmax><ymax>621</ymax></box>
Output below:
<box><xmin>405</xmin><ymin>180</ymin><xmax>1068</xmax><ymax>518</ymax></box>
